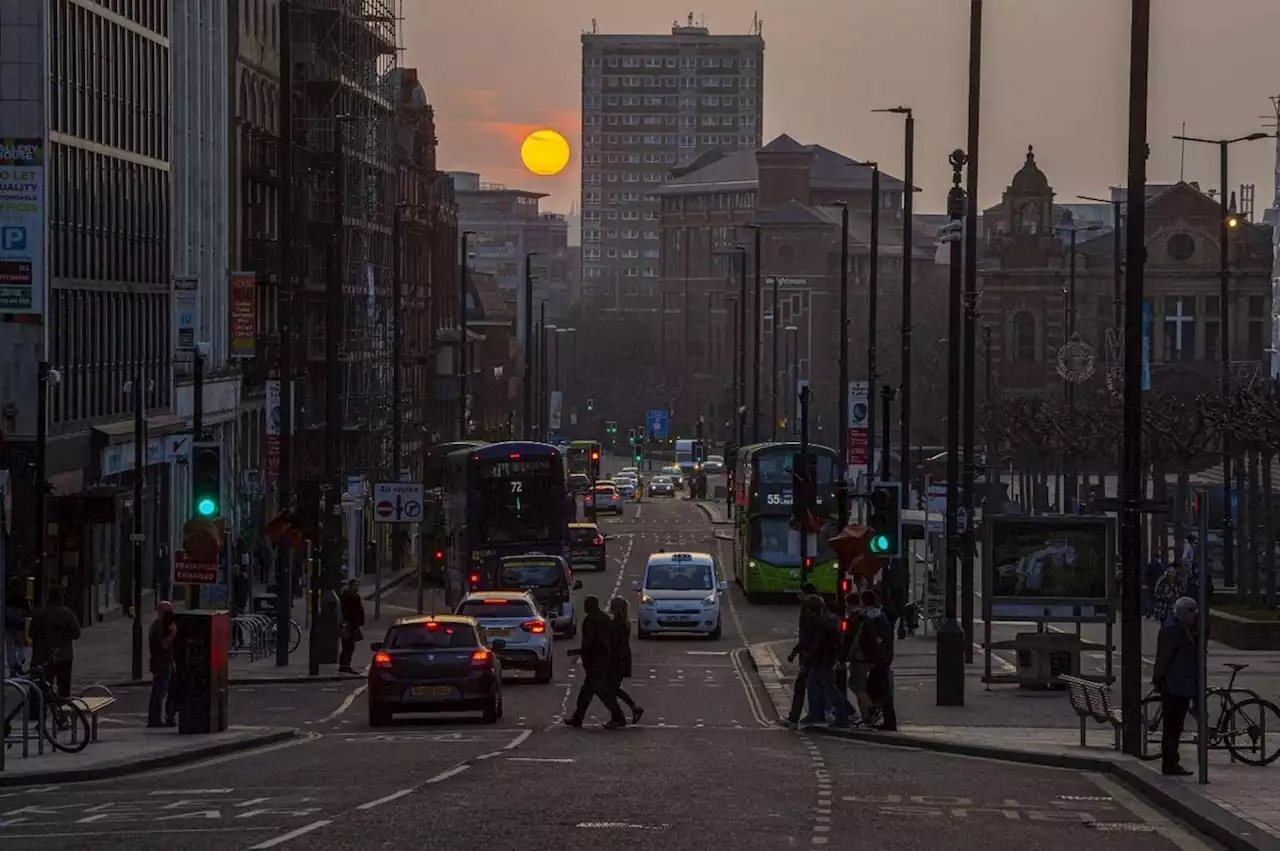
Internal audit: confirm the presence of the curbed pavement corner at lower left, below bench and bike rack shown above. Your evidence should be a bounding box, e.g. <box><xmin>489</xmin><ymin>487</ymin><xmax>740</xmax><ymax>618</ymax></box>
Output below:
<box><xmin>0</xmin><ymin>724</ymin><xmax>297</xmax><ymax>787</ymax></box>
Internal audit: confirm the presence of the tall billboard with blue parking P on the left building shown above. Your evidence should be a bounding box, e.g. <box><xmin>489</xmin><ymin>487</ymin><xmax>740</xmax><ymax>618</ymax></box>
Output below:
<box><xmin>0</xmin><ymin>138</ymin><xmax>45</xmax><ymax>315</ymax></box>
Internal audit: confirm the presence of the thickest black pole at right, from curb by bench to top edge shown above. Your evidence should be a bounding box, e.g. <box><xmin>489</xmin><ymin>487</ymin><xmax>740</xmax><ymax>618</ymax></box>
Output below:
<box><xmin>1120</xmin><ymin>0</ymin><xmax>1162</xmax><ymax>756</ymax></box>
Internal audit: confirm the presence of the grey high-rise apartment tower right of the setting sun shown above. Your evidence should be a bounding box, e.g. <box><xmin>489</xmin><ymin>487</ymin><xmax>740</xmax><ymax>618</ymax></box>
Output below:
<box><xmin>581</xmin><ymin>15</ymin><xmax>764</xmax><ymax>297</ymax></box>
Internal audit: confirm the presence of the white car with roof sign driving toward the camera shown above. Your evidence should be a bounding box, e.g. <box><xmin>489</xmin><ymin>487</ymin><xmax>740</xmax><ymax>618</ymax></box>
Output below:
<box><xmin>631</xmin><ymin>553</ymin><xmax>728</xmax><ymax>640</ymax></box>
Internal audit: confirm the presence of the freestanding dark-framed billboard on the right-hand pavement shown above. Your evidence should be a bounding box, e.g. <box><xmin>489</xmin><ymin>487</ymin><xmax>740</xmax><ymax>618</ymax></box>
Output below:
<box><xmin>982</xmin><ymin>514</ymin><xmax>1115</xmax><ymax>622</ymax></box>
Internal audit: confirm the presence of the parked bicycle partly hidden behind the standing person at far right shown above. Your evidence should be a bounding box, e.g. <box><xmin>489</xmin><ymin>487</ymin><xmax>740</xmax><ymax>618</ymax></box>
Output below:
<box><xmin>1142</xmin><ymin>662</ymin><xmax>1280</xmax><ymax>765</ymax></box>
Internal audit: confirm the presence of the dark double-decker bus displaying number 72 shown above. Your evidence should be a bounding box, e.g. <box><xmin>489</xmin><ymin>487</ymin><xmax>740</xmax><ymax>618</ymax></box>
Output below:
<box><xmin>444</xmin><ymin>441</ymin><xmax>575</xmax><ymax>607</ymax></box>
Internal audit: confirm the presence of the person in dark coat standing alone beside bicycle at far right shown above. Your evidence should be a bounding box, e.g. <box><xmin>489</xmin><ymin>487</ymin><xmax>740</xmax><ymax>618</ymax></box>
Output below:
<box><xmin>1151</xmin><ymin>596</ymin><xmax>1201</xmax><ymax>777</ymax></box>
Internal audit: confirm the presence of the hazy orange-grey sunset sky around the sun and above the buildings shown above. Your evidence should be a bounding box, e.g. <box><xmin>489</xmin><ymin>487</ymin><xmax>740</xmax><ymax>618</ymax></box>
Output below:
<box><xmin>403</xmin><ymin>0</ymin><xmax>1280</xmax><ymax>215</ymax></box>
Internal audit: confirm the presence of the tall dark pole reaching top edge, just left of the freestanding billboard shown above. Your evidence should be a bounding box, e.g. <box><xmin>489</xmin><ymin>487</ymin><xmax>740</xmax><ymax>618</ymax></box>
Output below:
<box><xmin>960</xmin><ymin>0</ymin><xmax>982</xmax><ymax>663</ymax></box>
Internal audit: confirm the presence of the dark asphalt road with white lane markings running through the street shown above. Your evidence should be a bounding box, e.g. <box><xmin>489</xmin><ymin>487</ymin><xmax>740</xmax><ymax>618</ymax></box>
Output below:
<box><xmin>0</xmin><ymin>478</ymin><xmax>1207</xmax><ymax>851</ymax></box>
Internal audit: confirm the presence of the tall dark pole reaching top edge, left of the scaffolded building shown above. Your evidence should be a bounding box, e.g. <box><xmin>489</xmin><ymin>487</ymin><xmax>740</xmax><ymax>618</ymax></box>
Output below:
<box><xmin>275</xmin><ymin>0</ymin><xmax>293</xmax><ymax>668</ymax></box>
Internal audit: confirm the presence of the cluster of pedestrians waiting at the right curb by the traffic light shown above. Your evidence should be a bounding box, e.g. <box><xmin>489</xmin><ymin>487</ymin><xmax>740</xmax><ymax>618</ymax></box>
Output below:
<box><xmin>782</xmin><ymin>584</ymin><xmax>897</xmax><ymax>731</ymax></box>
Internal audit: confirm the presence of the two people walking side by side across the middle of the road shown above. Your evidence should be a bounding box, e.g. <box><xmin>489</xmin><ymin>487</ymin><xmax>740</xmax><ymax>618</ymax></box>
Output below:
<box><xmin>564</xmin><ymin>595</ymin><xmax>644</xmax><ymax>729</ymax></box>
